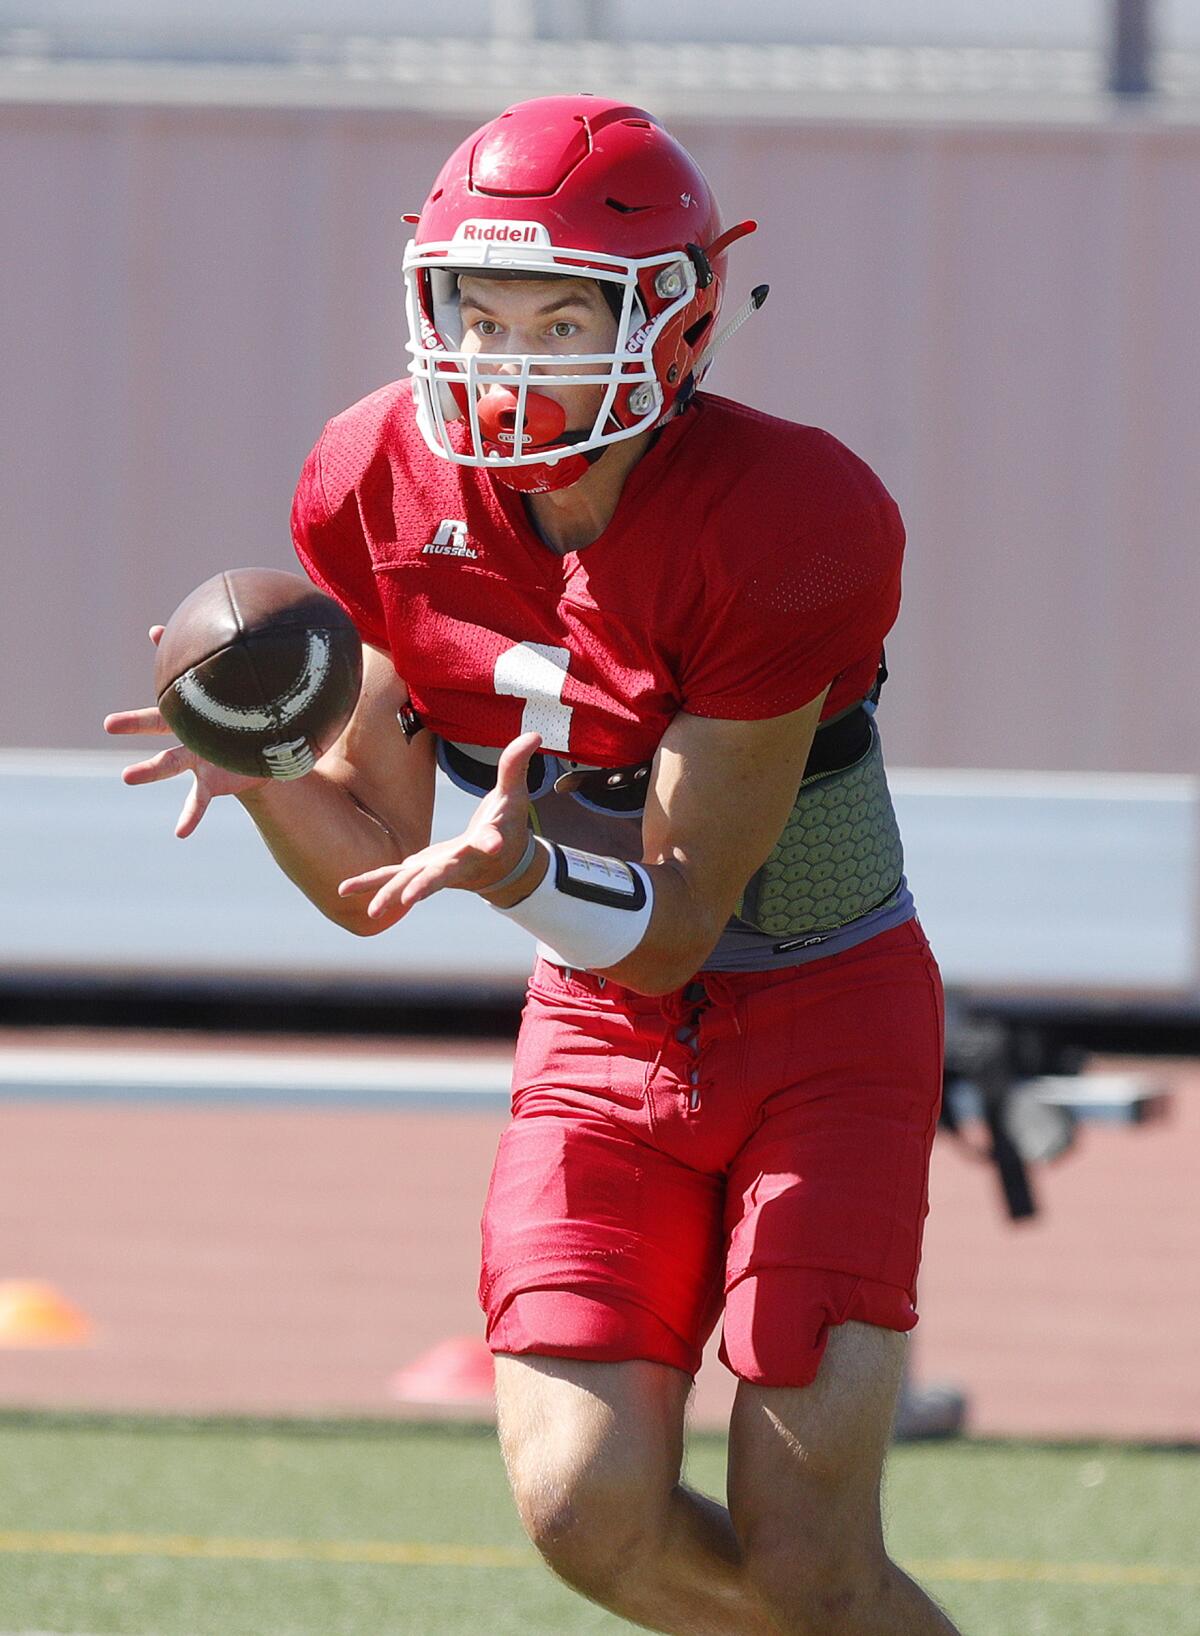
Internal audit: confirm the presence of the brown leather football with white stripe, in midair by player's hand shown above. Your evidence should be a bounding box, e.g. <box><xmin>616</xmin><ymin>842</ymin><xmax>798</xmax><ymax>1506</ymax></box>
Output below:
<box><xmin>154</xmin><ymin>568</ymin><xmax>362</xmax><ymax>779</ymax></box>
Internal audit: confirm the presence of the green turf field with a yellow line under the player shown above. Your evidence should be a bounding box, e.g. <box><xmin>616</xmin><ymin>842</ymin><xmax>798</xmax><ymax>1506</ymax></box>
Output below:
<box><xmin>0</xmin><ymin>1415</ymin><xmax>1200</xmax><ymax>1636</ymax></box>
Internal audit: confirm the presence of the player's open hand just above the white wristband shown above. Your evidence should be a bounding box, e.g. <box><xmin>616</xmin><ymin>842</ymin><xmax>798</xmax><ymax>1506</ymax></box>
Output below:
<box><xmin>337</xmin><ymin>733</ymin><xmax>542</xmax><ymax>928</ymax></box>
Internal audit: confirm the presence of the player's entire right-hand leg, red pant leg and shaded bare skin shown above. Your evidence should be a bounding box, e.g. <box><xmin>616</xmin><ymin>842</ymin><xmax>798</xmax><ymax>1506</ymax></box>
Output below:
<box><xmin>722</xmin><ymin>924</ymin><xmax>953</xmax><ymax>1636</ymax></box>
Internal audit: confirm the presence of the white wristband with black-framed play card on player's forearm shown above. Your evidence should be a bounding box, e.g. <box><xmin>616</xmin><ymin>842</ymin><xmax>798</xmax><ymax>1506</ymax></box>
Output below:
<box><xmin>493</xmin><ymin>836</ymin><xmax>655</xmax><ymax>970</ymax></box>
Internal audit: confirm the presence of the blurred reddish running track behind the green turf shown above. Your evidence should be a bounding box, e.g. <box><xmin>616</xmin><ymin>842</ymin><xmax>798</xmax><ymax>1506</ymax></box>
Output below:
<box><xmin>0</xmin><ymin>1031</ymin><xmax>1200</xmax><ymax>1440</ymax></box>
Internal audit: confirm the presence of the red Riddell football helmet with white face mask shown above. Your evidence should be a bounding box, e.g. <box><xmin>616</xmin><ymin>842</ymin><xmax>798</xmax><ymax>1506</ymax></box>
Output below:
<box><xmin>404</xmin><ymin>97</ymin><xmax>755</xmax><ymax>492</ymax></box>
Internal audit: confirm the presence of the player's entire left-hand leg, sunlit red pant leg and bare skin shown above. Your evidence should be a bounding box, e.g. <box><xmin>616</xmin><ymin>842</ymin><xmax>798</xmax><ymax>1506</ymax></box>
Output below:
<box><xmin>480</xmin><ymin>967</ymin><xmax>776</xmax><ymax>1636</ymax></box>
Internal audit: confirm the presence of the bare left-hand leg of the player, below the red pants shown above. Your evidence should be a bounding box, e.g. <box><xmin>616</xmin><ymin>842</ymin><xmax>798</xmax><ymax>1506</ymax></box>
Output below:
<box><xmin>496</xmin><ymin>1355</ymin><xmax>778</xmax><ymax>1636</ymax></box>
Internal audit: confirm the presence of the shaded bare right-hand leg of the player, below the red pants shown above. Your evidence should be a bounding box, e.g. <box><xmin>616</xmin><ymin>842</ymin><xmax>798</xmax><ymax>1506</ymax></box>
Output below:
<box><xmin>729</xmin><ymin>1321</ymin><xmax>954</xmax><ymax>1636</ymax></box>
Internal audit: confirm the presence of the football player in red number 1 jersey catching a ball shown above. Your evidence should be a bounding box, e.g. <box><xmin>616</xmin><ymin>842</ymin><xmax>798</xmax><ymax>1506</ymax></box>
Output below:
<box><xmin>115</xmin><ymin>97</ymin><xmax>953</xmax><ymax>1636</ymax></box>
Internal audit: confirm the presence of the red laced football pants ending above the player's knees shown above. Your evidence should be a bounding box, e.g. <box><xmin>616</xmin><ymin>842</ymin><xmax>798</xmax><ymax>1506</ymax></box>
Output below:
<box><xmin>480</xmin><ymin>921</ymin><xmax>943</xmax><ymax>1386</ymax></box>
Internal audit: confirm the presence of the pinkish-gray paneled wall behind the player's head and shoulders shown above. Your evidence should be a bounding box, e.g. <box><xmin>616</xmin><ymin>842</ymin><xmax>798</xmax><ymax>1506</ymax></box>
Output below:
<box><xmin>0</xmin><ymin>87</ymin><xmax>1200</xmax><ymax>772</ymax></box>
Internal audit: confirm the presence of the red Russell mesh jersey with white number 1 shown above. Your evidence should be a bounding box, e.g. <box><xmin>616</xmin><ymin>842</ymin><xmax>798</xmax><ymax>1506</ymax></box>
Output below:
<box><xmin>293</xmin><ymin>381</ymin><xmax>904</xmax><ymax>767</ymax></box>
